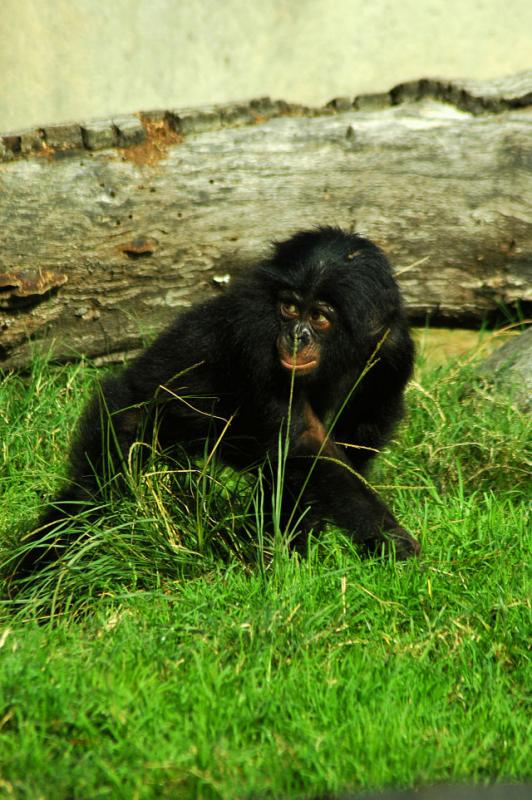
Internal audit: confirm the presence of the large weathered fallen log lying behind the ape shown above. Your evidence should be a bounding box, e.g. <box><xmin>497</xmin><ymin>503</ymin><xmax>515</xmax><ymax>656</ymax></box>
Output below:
<box><xmin>0</xmin><ymin>73</ymin><xmax>532</xmax><ymax>367</ymax></box>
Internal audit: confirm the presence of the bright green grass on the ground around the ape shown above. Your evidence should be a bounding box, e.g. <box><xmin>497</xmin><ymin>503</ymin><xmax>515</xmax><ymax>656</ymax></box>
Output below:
<box><xmin>0</xmin><ymin>346</ymin><xmax>531</xmax><ymax>800</ymax></box>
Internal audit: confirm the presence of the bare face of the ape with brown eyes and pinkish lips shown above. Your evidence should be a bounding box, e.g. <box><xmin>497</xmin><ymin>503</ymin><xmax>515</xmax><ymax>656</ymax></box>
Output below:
<box><xmin>277</xmin><ymin>290</ymin><xmax>336</xmax><ymax>378</ymax></box>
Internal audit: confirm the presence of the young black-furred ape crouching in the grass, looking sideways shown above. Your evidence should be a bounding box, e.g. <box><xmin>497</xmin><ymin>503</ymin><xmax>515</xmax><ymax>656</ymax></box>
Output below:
<box><xmin>22</xmin><ymin>228</ymin><xmax>419</xmax><ymax>571</ymax></box>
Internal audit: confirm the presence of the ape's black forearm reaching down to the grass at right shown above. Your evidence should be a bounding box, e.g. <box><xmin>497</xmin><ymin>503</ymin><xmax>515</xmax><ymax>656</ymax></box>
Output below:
<box><xmin>286</xmin><ymin>407</ymin><xmax>420</xmax><ymax>560</ymax></box>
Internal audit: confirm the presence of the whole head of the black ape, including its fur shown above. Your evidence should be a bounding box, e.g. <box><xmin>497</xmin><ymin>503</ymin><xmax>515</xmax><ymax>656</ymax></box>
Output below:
<box><xmin>256</xmin><ymin>229</ymin><xmax>396</xmax><ymax>385</ymax></box>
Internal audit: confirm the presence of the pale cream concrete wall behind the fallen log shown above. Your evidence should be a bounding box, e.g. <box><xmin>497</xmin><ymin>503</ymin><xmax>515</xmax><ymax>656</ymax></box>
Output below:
<box><xmin>0</xmin><ymin>0</ymin><xmax>532</xmax><ymax>132</ymax></box>
